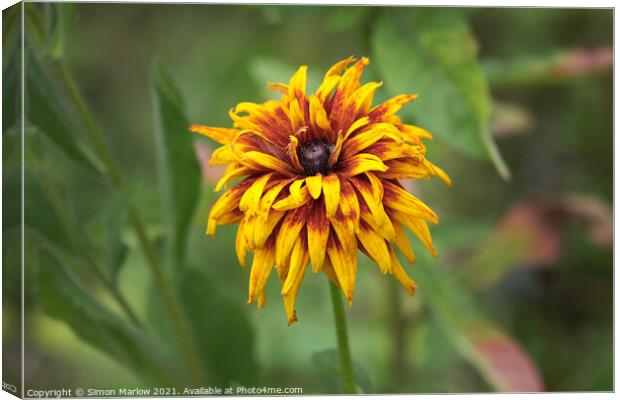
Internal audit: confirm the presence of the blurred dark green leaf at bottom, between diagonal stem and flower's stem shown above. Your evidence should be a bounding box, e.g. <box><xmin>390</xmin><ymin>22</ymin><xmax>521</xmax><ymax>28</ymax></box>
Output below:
<box><xmin>179</xmin><ymin>269</ymin><xmax>257</xmax><ymax>386</ymax></box>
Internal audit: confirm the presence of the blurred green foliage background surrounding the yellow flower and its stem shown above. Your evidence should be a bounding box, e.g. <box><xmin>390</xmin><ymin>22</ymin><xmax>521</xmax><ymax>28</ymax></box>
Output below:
<box><xmin>3</xmin><ymin>3</ymin><xmax>613</xmax><ymax>394</ymax></box>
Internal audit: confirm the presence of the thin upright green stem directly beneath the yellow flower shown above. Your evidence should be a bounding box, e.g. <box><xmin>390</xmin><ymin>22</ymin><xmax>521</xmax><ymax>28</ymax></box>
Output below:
<box><xmin>329</xmin><ymin>281</ymin><xmax>357</xmax><ymax>394</ymax></box>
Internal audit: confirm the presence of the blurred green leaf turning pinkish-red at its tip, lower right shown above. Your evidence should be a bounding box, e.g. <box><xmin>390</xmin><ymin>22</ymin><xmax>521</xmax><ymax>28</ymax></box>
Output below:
<box><xmin>415</xmin><ymin>257</ymin><xmax>543</xmax><ymax>392</ymax></box>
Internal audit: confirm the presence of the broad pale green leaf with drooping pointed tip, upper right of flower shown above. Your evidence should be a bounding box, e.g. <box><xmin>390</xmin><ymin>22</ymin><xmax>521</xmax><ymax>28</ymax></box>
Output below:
<box><xmin>372</xmin><ymin>8</ymin><xmax>510</xmax><ymax>179</ymax></box>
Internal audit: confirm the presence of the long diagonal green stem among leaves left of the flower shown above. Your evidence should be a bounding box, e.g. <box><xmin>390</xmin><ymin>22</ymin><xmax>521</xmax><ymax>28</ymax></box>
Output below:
<box><xmin>55</xmin><ymin>60</ymin><xmax>204</xmax><ymax>385</ymax></box>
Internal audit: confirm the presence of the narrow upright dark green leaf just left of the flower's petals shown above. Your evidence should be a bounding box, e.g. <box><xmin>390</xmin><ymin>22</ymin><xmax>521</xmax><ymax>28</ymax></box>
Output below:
<box><xmin>152</xmin><ymin>66</ymin><xmax>200</xmax><ymax>267</ymax></box>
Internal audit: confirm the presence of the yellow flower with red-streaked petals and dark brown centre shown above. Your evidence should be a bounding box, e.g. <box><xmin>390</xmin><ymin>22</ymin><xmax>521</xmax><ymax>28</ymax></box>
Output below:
<box><xmin>190</xmin><ymin>57</ymin><xmax>450</xmax><ymax>324</ymax></box>
